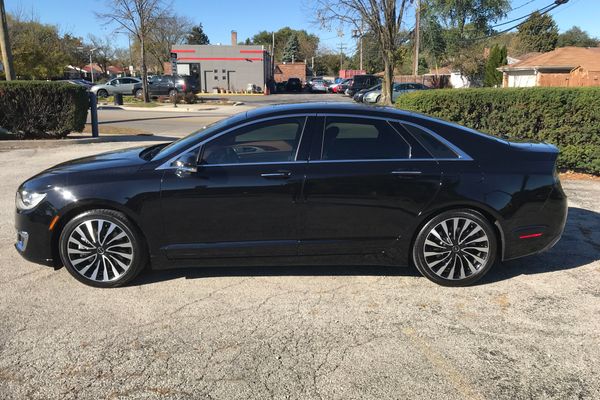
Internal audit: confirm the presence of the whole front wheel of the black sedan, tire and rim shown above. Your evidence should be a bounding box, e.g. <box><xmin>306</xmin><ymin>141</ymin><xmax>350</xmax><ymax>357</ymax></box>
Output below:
<box><xmin>58</xmin><ymin>209</ymin><xmax>148</xmax><ymax>288</ymax></box>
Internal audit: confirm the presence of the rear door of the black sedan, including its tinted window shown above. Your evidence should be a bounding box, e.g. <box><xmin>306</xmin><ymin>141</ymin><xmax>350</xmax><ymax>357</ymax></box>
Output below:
<box><xmin>300</xmin><ymin>115</ymin><xmax>441</xmax><ymax>255</ymax></box>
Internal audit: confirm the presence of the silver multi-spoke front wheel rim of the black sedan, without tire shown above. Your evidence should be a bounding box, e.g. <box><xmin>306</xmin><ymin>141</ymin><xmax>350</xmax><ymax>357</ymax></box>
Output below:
<box><xmin>66</xmin><ymin>219</ymin><xmax>134</xmax><ymax>282</ymax></box>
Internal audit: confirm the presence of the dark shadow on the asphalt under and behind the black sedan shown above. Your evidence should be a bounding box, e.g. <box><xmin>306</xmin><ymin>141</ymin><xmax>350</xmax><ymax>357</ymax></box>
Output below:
<box><xmin>130</xmin><ymin>207</ymin><xmax>600</xmax><ymax>286</ymax></box>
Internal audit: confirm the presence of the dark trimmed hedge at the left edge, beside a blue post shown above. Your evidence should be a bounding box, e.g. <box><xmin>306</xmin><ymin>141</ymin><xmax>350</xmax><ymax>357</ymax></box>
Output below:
<box><xmin>0</xmin><ymin>81</ymin><xmax>89</xmax><ymax>139</ymax></box>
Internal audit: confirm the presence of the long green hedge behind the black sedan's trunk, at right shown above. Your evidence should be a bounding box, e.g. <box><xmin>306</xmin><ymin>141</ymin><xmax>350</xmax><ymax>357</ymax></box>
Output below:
<box><xmin>396</xmin><ymin>88</ymin><xmax>600</xmax><ymax>174</ymax></box>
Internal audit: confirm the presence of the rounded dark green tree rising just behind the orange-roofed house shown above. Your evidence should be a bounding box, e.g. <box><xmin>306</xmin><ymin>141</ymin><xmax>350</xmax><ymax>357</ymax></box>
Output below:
<box><xmin>517</xmin><ymin>11</ymin><xmax>558</xmax><ymax>53</ymax></box>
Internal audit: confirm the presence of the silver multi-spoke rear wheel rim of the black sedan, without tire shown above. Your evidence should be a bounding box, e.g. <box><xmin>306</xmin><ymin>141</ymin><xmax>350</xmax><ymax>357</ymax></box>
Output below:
<box><xmin>423</xmin><ymin>217</ymin><xmax>490</xmax><ymax>280</ymax></box>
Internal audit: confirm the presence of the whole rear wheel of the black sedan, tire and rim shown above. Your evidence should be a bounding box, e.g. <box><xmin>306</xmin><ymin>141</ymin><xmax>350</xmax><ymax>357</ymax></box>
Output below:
<box><xmin>412</xmin><ymin>209</ymin><xmax>498</xmax><ymax>286</ymax></box>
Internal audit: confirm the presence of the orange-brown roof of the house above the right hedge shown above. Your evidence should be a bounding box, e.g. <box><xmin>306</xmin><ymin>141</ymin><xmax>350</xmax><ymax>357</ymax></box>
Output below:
<box><xmin>498</xmin><ymin>47</ymin><xmax>600</xmax><ymax>71</ymax></box>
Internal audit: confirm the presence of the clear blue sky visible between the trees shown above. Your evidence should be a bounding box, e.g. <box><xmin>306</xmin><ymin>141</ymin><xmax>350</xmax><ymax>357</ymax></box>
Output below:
<box><xmin>4</xmin><ymin>0</ymin><xmax>600</xmax><ymax>53</ymax></box>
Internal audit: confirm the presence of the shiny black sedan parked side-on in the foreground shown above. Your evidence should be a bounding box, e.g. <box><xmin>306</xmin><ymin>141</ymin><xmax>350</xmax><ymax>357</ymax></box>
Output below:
<box><xmin>16</xmin><ymin>103</ymin><xmax>567</xmax><ymax>287</ymax></box>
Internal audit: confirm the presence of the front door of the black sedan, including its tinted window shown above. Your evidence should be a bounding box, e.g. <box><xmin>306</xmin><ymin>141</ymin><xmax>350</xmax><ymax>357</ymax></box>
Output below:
<box><xmin>162</xmin><ymin>117</ymin><xmax>307</xmax><ymax>259</ymax></box>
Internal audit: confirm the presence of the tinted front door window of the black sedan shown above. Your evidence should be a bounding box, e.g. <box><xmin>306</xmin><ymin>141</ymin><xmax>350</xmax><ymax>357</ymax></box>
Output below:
<box><xmin>202</xmin><ymin>117</ymin><xmax>306</xmax><ymax>165</ymax></box>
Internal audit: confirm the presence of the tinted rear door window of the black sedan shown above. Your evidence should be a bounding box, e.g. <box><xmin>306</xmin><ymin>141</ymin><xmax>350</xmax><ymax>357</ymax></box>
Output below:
<box><xmin>321</xmin><ymin>117</ymin><xmax>411</xmax><ymax>160</ymax></box>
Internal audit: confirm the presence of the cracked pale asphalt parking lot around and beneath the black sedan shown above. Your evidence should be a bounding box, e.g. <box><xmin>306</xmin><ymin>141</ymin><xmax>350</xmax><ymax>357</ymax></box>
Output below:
<box><xmin>0</xmin><ymin>142</ymin><xmax>600</xmax><ymax>399</ymax></box>
